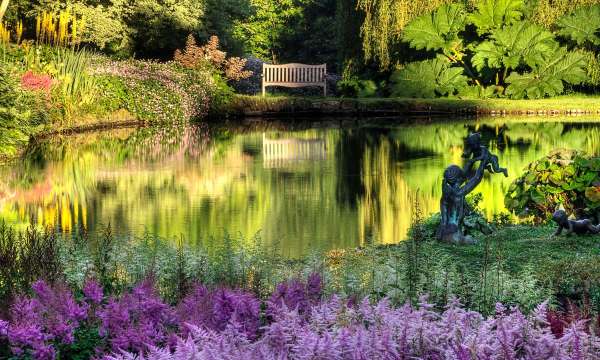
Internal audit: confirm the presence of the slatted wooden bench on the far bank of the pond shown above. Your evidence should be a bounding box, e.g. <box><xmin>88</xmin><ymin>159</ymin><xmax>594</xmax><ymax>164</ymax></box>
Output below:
<box><xmin>262</xmin><ymin>64</ymin><xmax>327</xmax><ymax>96</ymax></box>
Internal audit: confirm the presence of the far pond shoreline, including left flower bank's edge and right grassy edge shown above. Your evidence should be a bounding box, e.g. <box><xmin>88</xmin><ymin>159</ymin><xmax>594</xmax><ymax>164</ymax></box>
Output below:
<box><xmin>0</xmin><ymin>100</ymin><xmax>600</xmax><ymax>163</ymax></box>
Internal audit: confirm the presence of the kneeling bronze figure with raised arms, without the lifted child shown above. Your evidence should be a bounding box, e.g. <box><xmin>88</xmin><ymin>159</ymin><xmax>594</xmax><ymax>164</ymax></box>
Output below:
<box><xmin>437</xmin><ymin>160</ymin><xmax>488</xmax><ymax>244</ymax></box>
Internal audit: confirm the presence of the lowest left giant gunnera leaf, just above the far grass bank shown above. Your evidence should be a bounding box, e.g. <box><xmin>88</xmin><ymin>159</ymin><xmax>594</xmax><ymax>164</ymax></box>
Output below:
<box><xmin>390</xmin><ymin>57</ymin><xmax>468</xmax><ymax>98</ymax></box>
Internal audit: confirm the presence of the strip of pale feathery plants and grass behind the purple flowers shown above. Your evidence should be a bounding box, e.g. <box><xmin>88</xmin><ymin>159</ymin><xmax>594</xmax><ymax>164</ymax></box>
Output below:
<box><xmin>0</xmin><ymin>221</ymin><xmax>600</xmax><ymax>314</ymax></box>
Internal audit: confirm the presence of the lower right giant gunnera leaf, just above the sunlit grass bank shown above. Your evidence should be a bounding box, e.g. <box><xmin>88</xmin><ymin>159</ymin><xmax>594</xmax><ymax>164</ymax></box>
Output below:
<box><xmin>506</xmin><ymin>47</ymin><xmax>587</xmax><ymax>99</ymax></box>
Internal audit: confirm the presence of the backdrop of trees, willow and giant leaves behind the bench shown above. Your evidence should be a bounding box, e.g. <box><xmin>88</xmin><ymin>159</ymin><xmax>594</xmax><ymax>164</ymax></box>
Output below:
<box><xmin>7</xmin><ymin>0</ymin><xmax>600</xmax><ymax>99</ymax></box>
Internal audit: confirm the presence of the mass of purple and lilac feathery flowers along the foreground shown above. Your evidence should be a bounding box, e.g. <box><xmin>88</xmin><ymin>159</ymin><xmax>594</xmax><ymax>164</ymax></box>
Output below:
<box><xmin>0</xmin><ymin>274</ymin><xmax>600</xmax><ymax>360</ymax></box>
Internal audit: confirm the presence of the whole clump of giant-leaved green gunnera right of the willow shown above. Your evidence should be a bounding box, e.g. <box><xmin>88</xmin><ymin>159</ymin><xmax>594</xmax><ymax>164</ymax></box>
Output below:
<box><xmin>391</xmin><ymin>0</ymin><xmax>594</xmax><ymax>99</ymax></box>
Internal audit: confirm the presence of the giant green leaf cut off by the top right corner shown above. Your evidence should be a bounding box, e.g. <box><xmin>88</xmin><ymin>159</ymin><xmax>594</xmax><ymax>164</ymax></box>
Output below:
<box><xmin>556</xmin><ymin>4</ymin><xmax>600</xmax><ymax>45</ymax></box>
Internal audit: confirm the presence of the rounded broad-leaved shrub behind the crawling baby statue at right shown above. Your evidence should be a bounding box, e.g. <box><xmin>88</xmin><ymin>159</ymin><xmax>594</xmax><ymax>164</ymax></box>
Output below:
<box><xmin>504</xmin><ymin>149</ymin><xmax>600</xmax><ymax>220</ymax></box>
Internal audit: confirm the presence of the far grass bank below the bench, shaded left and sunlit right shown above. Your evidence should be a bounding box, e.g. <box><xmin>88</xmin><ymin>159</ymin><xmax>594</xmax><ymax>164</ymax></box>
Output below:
<box><xmin>224</xmin><ymin>94</ymin><xmax>600</xmax><ymax>117</ymax></box>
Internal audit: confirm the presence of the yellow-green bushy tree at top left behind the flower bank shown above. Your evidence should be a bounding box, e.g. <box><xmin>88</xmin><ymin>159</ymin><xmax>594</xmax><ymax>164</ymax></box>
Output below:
<box><xmin>38</xmin><ymin>0</ymin><xmax>205</xmax><ymax>57</ymax></box>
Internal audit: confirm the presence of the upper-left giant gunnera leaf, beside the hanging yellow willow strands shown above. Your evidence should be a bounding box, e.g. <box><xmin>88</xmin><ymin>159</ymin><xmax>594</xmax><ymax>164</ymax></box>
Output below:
<box><xmin>402</xmin><ymin>4</ymin><xmax>467</xmax><ymax>53</ymax></box>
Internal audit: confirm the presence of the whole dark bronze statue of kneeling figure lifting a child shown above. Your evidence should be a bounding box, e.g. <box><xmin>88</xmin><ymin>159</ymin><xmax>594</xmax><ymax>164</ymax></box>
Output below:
<box><xmin>437</xmin><ymin>133</ymin><xmax>507</xmax><ymax>244</ymax></box>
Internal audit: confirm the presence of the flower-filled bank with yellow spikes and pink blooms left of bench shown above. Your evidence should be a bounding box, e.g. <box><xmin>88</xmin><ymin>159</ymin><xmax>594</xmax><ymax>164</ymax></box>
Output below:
<box><xmin>0</xmin><ymin>25</ymin><xmax>238</xmax><ymax>155</ymax></box>
